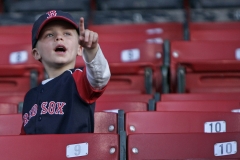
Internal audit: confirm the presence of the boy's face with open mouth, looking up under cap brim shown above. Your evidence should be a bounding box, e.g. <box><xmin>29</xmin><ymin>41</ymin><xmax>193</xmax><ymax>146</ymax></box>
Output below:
<box><xmin>33</xmin><ymin>20</ymin><xmax>81</xmax><ymax>68</ymax></box>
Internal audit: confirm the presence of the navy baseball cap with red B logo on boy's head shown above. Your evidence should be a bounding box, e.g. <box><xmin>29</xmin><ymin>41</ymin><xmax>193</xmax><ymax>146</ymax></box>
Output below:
<box><xmin>32</xmin><ymin>10</ymin><xmax>78</xmax><ymax>48</ymax></box>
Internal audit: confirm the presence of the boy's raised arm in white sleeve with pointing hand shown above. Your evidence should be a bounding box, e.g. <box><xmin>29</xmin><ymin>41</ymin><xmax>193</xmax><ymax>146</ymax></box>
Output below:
<box><xmin>79</xmin><ymin>17</ymin><xmax>111</xmax><ymax>89</ymax></box>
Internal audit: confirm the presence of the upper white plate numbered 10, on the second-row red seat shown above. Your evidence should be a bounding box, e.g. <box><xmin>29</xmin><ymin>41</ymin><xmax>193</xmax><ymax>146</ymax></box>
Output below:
<box><xmin>204</xmin><ymin>121</ymin><xmax>226</xmax><ymax>133</ymax></box>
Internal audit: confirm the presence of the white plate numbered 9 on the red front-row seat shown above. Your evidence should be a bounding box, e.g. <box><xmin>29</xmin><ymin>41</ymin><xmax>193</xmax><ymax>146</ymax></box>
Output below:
<box><xmin>66</xmin><ymin>143</ymin><xmax>88</xmax><ymax>158</ymax></box>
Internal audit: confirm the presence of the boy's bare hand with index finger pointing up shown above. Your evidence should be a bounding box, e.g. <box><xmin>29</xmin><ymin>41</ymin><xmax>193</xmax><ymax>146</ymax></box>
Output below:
<box><xmin>79</xmin><ymin>17</ymin><xmax>98</xmax><ymax>50</ymax></box>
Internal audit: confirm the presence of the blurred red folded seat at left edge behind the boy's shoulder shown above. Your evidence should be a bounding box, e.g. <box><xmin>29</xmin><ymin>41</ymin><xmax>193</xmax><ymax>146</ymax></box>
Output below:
<box><xmin>0</xmin><ymin>44</ymin><xmax>45</xmax><ymax>93</ymax></box>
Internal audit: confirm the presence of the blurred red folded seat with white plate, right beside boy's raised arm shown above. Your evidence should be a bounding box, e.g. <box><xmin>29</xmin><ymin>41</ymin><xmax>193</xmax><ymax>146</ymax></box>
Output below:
<box><xmin>76</xmin><ymin>42</ymin><xmax>162</xmax><ymax>94</ymax></box>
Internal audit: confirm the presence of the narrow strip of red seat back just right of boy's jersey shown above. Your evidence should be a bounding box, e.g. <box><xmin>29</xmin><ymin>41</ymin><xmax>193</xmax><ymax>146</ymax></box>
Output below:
<box><xmin>95</xmin><ymin>101</ymin><xmax>148</xmax><ymax>112</ymax></box>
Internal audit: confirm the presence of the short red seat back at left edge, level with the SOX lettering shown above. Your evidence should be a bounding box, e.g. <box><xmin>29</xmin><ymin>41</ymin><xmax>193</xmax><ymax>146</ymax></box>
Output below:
<box><xmin>0</xmin><ymin>102</ymin><xmax>18</xmax><ymax>115</ymax></box>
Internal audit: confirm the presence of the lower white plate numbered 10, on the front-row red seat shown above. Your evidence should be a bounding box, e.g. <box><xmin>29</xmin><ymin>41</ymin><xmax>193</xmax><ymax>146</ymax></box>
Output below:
<box><xmin>214</xmin><ymin>141</ymin><xmax>237</xmax><ymax>156</ymax></box>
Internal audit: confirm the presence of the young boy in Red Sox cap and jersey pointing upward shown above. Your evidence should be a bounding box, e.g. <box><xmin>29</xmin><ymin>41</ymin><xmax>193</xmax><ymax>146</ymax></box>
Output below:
<box><xmin>21</xmin><ymin>10</ymin><xmax>110</xmax><ymax>134</ymax></box>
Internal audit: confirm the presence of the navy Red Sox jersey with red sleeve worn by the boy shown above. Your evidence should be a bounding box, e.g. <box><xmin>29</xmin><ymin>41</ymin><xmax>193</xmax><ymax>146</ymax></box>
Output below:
<box><xmin>21</xmin><ymin>69</ymin><xmax>105</xmax><ymax>134</ymax></box>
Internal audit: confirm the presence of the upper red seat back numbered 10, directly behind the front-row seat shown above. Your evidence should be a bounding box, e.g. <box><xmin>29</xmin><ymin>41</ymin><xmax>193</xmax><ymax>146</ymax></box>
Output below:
<box><xmin>125</xmin><ymin>111</ymin><xmax>240</xmax><ymax>135</ymax></box>
